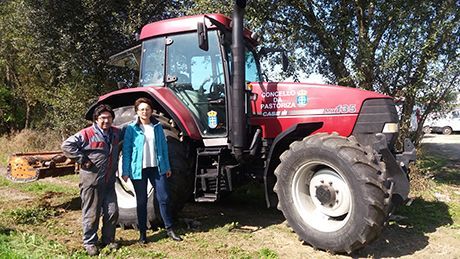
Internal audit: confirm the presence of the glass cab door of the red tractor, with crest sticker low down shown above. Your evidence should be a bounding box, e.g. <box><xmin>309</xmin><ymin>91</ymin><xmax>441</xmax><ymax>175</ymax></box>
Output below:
<box><xmin>166</xmin><ymin>31</ymin><xmax>227</xmax><ymax>137</ymax></box>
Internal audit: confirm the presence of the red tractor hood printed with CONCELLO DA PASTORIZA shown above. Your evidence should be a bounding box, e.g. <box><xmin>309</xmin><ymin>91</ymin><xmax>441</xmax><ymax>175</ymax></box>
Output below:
<box><xmin>246</xmin><ymin>82</ymin><xmax>392</xmax><ymax>138</ymax></box>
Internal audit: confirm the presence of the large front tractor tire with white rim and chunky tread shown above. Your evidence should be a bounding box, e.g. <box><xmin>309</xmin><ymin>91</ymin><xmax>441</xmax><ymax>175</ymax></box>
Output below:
<box><xmin>274</xmin><ymin>133</ymin><xmax>388</xmax><ymax>253</ymax></box>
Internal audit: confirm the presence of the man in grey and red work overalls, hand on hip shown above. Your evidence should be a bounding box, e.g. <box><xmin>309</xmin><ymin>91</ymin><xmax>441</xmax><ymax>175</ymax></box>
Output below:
<box><xmin>62</xmin><ymin>104</ymin><xmax>121</xmax><ymax>256</ymax></box>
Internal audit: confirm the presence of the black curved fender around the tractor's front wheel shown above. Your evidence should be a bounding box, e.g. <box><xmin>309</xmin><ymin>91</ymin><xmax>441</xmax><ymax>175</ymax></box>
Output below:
<box><xmin>264</xmin><ymin>122</ymin><xmax>323</xmax><ymax>208</ymax></box>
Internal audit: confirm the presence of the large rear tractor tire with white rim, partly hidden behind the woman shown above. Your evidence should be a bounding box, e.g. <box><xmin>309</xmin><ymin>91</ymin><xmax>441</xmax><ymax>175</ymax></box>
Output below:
<box><xmin>114</xmin><ymin>106</ymin><xmax>193</xmax><ymax>228</ymax></box>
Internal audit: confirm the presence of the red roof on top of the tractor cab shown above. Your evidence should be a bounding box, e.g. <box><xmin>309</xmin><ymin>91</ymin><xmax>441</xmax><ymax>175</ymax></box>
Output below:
<box><xmin>140</xmin><ymin>14</ymin><xmax>255</xmax><ymax>43</ymax></box>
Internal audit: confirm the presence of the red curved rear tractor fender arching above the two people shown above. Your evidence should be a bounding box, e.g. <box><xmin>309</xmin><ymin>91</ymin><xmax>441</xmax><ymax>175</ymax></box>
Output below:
<box><xmin>85</xmin><ymin>87</ymin><xmax>201</xmax><ymax>140</ymax></box>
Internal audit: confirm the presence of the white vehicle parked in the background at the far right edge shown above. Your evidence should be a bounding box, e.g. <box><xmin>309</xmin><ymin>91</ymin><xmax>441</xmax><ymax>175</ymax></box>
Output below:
<box><xmin>423</xmin><ymin>108</ymin><xmax>460</xmax><ymax>135</ymax></box>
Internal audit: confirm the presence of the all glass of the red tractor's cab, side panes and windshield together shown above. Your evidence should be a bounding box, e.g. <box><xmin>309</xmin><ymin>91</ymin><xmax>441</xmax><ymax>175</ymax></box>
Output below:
<box><xmin>140</xmin><ymin>30</ymin><xmax>260</xmax><ymax>138</ymax></box>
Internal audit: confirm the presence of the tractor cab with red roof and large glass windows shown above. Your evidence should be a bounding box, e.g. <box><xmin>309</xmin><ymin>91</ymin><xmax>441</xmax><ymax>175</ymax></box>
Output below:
<box><xmin>110</xmin><ymin>14</ymin><xmax>260</xmax><ymax>142</ymax></box>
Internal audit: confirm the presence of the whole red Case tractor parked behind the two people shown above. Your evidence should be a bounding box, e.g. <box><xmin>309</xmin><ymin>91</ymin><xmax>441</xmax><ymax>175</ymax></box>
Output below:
<box><xmin>86</xmin><ymin>1</ymin><xmax>415</xmax><ymax>253</ymax></box>
